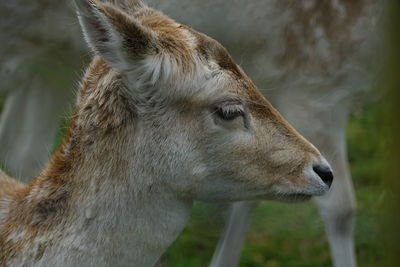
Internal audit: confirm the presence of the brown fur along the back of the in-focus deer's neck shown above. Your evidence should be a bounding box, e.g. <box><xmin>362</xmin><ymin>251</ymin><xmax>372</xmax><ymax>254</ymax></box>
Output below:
<box><xmin>0</xmin><ymin>55</ymin><xmax>131</xmax><ymax>266</ymax></box>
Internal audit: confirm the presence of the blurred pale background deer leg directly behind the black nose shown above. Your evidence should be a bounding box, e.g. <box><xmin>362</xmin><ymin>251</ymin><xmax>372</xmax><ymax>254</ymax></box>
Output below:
<box><xmin>279</xmin><ymin>94</ymin><xmax>356</xmax><ymax>267</ymax></box>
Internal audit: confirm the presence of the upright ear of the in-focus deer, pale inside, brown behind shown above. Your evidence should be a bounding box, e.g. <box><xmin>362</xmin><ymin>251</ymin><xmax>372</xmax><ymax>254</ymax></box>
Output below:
<box><xmin>75</xmin><ymin>0</ymin><xmax>158</xmax><ymax>71</ymax></box>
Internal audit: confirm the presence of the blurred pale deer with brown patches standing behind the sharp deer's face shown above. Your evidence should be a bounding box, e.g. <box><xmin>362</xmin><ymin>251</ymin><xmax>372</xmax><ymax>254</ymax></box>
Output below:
<box><xmin>150</xmin><ymin>0</ymin><xmax>385</xmax><ymax>267</ymax></box>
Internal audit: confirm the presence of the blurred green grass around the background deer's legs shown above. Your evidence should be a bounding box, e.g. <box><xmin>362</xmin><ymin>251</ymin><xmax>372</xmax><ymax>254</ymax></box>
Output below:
<box><xmin>163</xmin><ymin>101</ymin><xmax>385</xmax><ymax>267</ymax></box>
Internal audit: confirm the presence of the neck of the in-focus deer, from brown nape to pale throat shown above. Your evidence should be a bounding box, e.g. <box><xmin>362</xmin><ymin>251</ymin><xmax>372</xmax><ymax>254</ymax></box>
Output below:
<box><xmin>5</xmin><ymin>60</ymin><xmax>192</xmax><ymax>266</ymax></box>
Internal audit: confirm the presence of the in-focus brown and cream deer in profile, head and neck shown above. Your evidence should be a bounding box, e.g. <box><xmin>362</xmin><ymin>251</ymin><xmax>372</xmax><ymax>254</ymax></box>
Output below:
<box><xmin>0</xmin><ymin>0</ymin><xmax>333</xmax><ymax>266</ymax></box>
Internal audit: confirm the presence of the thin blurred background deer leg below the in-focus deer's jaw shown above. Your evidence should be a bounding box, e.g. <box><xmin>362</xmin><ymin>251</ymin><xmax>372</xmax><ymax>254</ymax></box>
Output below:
<box><xmin>210</xmin><ymin>202</ymin><xmax>257</xmax><ymax>267</ymax></box>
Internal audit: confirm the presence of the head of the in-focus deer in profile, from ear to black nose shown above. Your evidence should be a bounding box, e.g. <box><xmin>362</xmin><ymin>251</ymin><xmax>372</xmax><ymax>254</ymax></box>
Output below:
<box><xmin>73</xmin><ymin>0</ymin><xmax>333</xmax><ymax>201</ymax></box>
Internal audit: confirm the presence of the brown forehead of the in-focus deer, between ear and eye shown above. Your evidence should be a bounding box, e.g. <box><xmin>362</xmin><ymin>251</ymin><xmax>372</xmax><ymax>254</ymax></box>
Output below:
<box><xmin>130</xmin><ymin>8</ymin><xmax>247</xmax><ymax>86</ymax></box>
